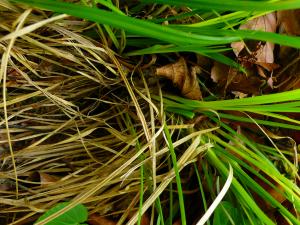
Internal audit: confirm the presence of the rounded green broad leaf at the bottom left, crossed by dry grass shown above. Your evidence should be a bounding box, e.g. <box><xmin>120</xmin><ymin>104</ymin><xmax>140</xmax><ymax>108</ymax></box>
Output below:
<box><xmin>36</xmin><ymin>202</ymin><xmax>88</xmax><ymax>225</ymax></box>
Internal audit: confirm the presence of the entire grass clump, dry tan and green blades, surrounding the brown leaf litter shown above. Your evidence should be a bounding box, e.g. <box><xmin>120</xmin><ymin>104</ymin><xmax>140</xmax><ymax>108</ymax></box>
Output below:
<box><xmin>0</xmin><ymin>0</ymin><xmax>300</xmax><ymax>225</ymax></box>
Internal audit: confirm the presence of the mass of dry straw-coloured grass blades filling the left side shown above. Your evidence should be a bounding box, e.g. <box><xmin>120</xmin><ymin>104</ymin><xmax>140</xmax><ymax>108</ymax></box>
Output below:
<box><xmin>0</xmin><ymin>1</ymin><xmax>210</xmax><ymax>224</ymax></box>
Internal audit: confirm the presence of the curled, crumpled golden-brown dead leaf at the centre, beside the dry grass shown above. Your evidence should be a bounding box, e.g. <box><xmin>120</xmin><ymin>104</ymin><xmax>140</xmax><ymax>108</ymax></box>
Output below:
<box><xmin>156</xmin><ymin>57</ymin><xmax>202</xmax><ymax>100</ymax></box>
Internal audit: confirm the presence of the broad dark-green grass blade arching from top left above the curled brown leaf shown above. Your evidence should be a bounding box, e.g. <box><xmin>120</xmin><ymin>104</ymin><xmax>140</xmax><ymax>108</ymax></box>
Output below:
<box><xmin>8</xmin><ymin>0</ymin><xmax>239</xmax><ymax>46</ymax></box>
